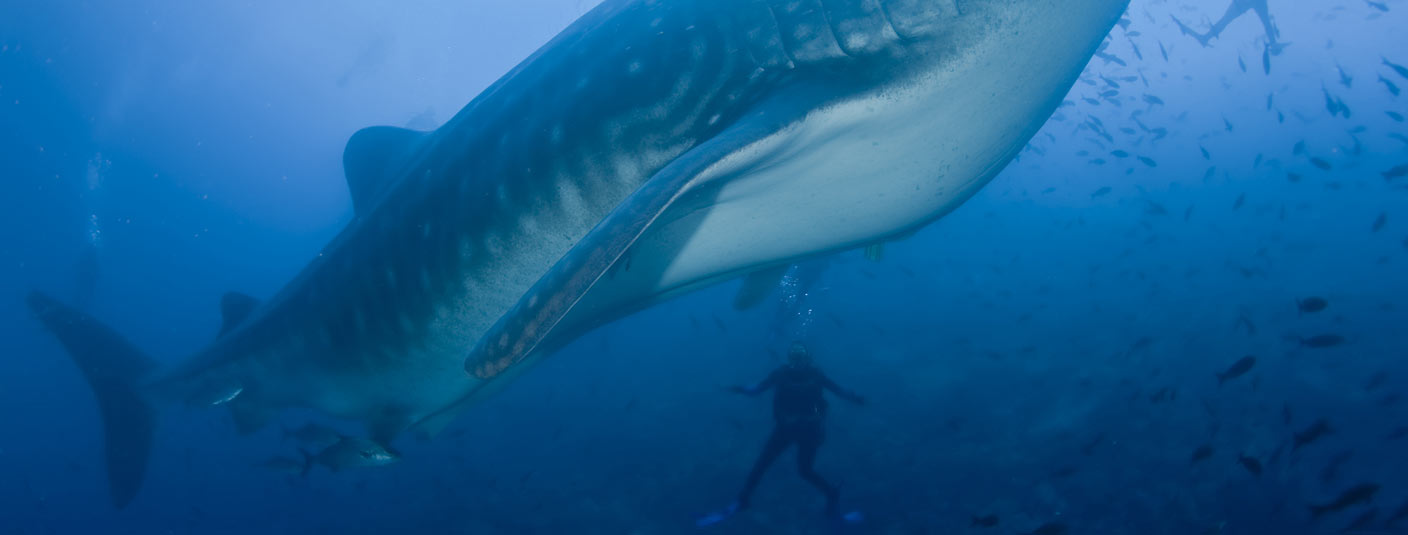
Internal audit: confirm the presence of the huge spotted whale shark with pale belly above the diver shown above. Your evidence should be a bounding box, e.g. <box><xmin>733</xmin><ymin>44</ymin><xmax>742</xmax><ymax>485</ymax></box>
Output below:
<box><xmin>27</xmin><ymin>0</ymin><xmax>1128</xmax><ymax>507</ymax></box>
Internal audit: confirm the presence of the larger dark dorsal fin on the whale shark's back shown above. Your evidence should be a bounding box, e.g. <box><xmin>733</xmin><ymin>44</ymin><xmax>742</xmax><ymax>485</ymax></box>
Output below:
<box><xmin>342</xmin><ymin>127</ymin><xmax>428</xmax><ymax>217</ymax></box>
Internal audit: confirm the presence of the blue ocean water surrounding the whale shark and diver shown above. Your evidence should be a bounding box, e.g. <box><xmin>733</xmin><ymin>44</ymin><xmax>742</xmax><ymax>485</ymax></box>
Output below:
<box><xmin>0</xmin><ymin>0</ymin><xmax>1408</xmax><ymax>535</ymax></box>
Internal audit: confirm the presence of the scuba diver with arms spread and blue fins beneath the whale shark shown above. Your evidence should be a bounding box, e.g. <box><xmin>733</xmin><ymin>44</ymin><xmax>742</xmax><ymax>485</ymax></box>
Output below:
<box><xmin>696</xmin><ymin>342</ymin><xmax>866</xmax><ymax>528</ymax></box>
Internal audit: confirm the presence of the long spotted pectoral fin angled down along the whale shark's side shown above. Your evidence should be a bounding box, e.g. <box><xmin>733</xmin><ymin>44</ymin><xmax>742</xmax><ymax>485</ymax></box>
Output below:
<box><xmin>465</xmin><ymin>118</ymin><xmax>786</xmax><ymax>380</ymax></box>
